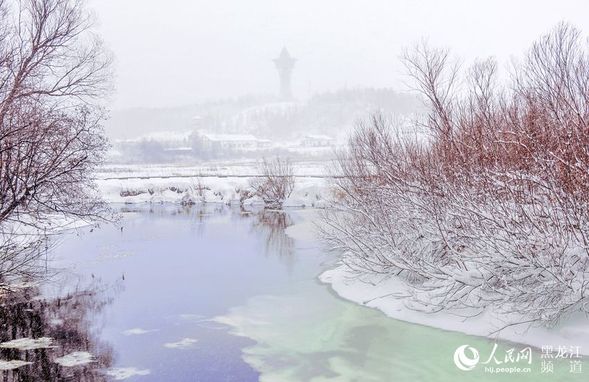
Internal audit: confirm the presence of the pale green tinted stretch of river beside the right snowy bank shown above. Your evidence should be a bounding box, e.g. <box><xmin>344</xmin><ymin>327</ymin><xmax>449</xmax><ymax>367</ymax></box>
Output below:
<box><xmin>219</xmin><ymin>281</ymin><xmax>587</xmax><ymax>382</ymax></box>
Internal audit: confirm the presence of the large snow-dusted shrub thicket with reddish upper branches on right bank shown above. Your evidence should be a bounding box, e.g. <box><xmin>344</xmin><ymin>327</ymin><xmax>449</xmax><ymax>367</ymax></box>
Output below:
<box><xmin>325</xmin><ymin>24</ymin><xmax>589</xmax><ymax>325</ymax></box>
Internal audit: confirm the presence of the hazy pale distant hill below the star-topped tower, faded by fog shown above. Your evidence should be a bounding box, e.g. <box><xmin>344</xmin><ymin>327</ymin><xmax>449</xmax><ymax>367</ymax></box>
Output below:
<box><xmin>105</xmin><ymin>88</ymin><xmax>422</xmax><ymax>140</ymax></box>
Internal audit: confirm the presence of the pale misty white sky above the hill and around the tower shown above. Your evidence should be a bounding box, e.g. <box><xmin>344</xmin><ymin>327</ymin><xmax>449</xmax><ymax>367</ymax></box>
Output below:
<box><xmin>88</xmin><ymin>0</ymin><xmax>589</xmax><ymax>109</ymax></box>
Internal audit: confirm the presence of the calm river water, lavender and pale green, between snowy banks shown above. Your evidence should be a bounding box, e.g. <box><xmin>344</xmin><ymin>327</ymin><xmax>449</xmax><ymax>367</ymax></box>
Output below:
<box><xmin>0</xmin><ymin>205</ymin><xmax>589</xmax><ymax>382</ymax></box>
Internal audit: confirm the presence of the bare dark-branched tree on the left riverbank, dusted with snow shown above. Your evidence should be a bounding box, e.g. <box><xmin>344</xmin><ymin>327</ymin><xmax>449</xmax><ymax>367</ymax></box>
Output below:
<box><xmin>0</xmin><ymin>0</ymin><xmax>110</xmax><ymax>280</ymax></box>
